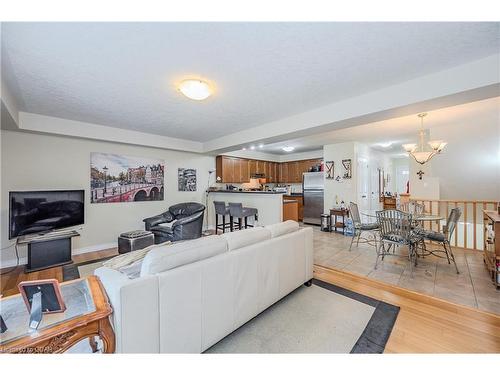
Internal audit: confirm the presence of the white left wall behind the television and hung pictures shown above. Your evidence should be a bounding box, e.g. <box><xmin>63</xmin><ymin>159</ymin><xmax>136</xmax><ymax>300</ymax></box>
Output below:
<box><xmin>0</xmin><ymin>131</ymin><xmax>215</xmax><ymax>263</ymax></box>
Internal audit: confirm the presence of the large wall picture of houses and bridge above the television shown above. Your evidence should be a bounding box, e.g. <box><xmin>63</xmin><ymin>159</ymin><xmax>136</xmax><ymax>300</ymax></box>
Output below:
<box><xmin>90</xmin><ymin>152</ymin><xmax>165</xmax><ymax>203</ymax></box>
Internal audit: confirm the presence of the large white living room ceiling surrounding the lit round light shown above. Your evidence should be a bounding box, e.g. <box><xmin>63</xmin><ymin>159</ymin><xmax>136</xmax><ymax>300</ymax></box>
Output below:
<box><xmin>2</xmin><ymin>23</ymin><xmax>499</xmax><ymax>144</ymax></box>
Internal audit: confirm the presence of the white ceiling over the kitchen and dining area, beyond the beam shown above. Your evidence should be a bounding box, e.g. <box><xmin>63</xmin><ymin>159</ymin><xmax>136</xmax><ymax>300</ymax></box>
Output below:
<box><xmin>260</xmin><ymin>97</ymin><xmax>500</xmax><ymax>157</ymax></box>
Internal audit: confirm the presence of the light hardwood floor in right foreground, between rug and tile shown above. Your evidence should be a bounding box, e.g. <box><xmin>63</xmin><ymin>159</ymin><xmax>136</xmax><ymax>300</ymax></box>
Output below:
<box><xmin>314</xmin><ymin>266</ymin><xmax>500</xmax><ymax>353</ymax></box>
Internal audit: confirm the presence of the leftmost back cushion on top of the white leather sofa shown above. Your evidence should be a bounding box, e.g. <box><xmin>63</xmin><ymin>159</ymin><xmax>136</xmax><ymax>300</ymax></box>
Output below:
<box><xmin>141</xmin><ymin>236</ymin><xmax>227</xmax><ymax>277</ymax></box>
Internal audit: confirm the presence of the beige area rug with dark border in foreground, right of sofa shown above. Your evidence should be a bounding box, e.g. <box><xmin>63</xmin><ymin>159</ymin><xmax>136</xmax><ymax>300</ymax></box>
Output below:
<box><xmin>205</xmin><ymin>280</ymin><xmax>399</xmax><ymax>353</ymax></box>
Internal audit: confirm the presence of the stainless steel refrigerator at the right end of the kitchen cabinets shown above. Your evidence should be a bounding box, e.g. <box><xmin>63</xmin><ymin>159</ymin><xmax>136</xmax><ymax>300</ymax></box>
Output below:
<box><xmin>302</xmin><ymin>172</ymin><xmax>325</xmax><ymax>225</ymax></box>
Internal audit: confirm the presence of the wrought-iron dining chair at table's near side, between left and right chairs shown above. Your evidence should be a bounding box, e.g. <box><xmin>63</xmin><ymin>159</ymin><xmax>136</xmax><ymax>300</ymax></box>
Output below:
<box><xmin>375</xmin><ymin>210</ymin><xmax>419</xmax><ymax>275</ymax></box>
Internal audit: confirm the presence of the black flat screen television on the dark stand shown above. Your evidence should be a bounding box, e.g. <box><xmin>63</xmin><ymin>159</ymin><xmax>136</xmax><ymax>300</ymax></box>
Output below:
<box><xmin>9</xmin><ymin>190</ymin><xmax>85</xmax><ymax>239</ymax></box>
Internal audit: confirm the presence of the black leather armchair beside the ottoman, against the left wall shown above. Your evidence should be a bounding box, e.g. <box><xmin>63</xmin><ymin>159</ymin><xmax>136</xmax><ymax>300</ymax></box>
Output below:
<box><xmin>143</xmin><ymin>202</ymin><xmax>205</xmax><ymax>244</ymax></box>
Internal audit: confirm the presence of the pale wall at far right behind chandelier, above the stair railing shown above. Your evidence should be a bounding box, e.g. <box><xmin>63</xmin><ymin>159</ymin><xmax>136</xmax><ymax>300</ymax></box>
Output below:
<box><xmin>410</xmin><ymin>98</ymin><xmax>500</xmax><ymax>201</ymax></box>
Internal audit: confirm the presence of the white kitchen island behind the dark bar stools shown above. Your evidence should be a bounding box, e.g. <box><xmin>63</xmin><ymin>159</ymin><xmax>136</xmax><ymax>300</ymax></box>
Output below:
<box><xmin>207</xmin><ymin>190</ymin><xmax>283</xmax><ymax>228</ymax></box>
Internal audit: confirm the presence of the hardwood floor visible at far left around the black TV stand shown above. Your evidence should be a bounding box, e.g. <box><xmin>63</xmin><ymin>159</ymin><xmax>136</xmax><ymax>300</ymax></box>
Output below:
<box><xmin>0</xmin><ymin>248</ymin><xmax>118</xmax><ymax>297</ymax></box>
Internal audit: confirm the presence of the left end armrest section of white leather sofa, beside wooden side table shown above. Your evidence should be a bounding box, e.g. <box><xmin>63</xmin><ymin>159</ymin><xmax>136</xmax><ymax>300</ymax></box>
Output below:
<box><xmin>94</xmin><ymin>267</ymin><xmax>160</xmax><ymax>353</ymax></box>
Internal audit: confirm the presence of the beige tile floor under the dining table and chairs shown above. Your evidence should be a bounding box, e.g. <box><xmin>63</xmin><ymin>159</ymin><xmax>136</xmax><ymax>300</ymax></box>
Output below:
<box><xmin>313</xmin><ymin>227</ymin><xmax>500</xmax><ymax>315</ymax></box>
